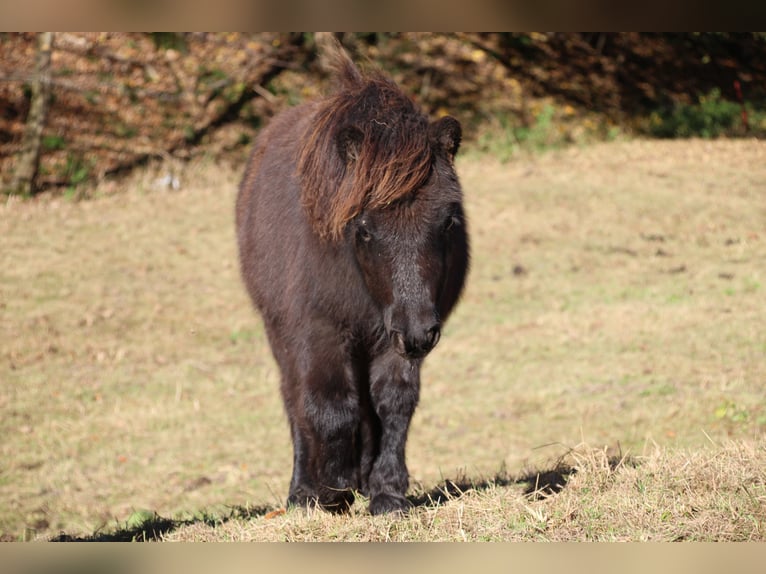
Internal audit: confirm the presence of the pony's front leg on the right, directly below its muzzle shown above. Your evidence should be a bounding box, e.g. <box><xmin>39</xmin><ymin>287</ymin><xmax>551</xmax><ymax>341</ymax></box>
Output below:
<box><xmin>369</xmin><ymin>351</ymin><xmax>420</xmax><ymax>514</ymax></box>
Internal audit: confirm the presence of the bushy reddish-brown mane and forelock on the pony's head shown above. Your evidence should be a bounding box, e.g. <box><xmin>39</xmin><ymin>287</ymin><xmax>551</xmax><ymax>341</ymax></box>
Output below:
<box><xmin>298</xmin><ymin>47</ymin><xmax>432</xmax><ymax>240</ymax></box>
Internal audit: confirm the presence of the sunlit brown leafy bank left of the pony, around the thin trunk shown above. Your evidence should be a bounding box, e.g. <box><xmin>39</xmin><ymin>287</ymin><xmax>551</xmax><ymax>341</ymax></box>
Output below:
<box><xmin>0</xmin><ymin>32</ymin><xmax>306</xmax><ymax>196</ymax></box>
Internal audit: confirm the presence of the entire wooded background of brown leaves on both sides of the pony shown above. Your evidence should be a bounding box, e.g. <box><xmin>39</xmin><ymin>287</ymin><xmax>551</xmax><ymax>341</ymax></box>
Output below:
<box><xmin>0</xmin><ymin>32</ymin><xmax>766</xmax><ymax>196</ymax></box>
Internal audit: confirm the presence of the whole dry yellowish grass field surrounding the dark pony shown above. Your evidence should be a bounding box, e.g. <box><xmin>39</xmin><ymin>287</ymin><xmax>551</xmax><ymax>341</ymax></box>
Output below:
<box><xmin>0</xmin><ymin>140</ymin><xmax>766</xmax><ymax>540</ymax></box>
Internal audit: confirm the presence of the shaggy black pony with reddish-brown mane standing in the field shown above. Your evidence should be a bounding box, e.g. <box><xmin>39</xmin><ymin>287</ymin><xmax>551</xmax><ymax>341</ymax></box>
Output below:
<box><xmin>236</xmin><ymin>43</ymin><xmax>468</xmax><ymax>514</ymax></box>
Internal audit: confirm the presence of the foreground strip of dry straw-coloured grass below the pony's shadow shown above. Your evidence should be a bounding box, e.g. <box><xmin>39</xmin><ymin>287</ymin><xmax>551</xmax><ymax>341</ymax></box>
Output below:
<box><xmin>163</xmin><ymin>442</ymin><xmax>766</xmax><ymax>542</ymax></box>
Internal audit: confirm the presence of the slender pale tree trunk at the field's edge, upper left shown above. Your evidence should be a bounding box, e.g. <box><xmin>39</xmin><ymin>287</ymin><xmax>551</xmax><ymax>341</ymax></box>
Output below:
<box><xmin>9</xmin><ymin>32</ymin><xmax>53</xmax><ymax>195</ymax></box>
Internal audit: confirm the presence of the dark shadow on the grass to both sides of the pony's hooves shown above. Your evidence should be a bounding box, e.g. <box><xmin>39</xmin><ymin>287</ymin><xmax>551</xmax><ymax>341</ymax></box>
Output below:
<box><xmin>51</xmin><ymin>456</ymin><xmax>625</xmax><ymax>542</ymax></box>
